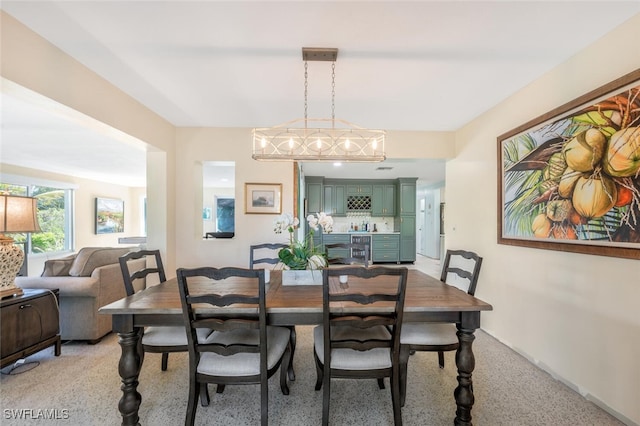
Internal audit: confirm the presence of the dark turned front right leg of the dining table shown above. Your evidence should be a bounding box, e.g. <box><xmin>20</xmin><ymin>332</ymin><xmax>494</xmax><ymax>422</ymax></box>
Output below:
<box><xmin>454</xmin><ymin>312</ymin><xmax>480</xmax><ymax>426</ymax></box>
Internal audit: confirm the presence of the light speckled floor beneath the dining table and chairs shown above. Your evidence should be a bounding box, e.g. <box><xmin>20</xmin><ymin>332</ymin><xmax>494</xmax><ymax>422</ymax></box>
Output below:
<box><xmin>0</xmin><ymin>327</ymin><xmax>622</xmax><ymax>426</ymax></box>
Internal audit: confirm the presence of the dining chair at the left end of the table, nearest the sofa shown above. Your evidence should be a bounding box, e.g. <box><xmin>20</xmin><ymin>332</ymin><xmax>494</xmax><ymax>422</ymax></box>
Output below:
<box><xmin>118</xmin><ymin>250</ymin><xmax>187</xmax><ymax>371</ymax></box>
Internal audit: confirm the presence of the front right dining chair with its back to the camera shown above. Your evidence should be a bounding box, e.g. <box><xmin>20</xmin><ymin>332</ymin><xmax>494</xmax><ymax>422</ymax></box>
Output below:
<box><xmin>313</xmin><ymin>266</ymin><xmax>407</xmax><ymax>425</ymax></box>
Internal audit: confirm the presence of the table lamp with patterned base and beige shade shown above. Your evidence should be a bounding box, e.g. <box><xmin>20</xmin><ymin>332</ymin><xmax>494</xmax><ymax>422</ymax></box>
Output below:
<box><xmin>0</xmin><ymin>194</ymin><xmax>40</xmax><ymax>298</ymax></box>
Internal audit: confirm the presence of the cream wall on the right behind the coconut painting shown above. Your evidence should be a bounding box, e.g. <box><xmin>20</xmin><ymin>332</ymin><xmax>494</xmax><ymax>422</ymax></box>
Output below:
<box><xmin>445</xmin><ymin>15</ymin><xmax>640</xmax><ymax>424</ymax></box>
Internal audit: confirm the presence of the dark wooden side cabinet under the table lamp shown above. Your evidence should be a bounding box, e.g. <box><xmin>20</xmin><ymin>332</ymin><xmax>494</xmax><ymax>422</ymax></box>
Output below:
<box><xmin>0</xmin><ymin>289</ymin><xmax>61</xmax><ymax>368</ymax></box>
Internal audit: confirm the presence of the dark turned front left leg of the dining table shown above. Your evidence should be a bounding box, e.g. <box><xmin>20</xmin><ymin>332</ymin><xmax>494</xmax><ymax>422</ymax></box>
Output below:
<box><xmin>118</xmin><ymin>328</ymin><xmax>144</xmax><ymax>425</ymax></box>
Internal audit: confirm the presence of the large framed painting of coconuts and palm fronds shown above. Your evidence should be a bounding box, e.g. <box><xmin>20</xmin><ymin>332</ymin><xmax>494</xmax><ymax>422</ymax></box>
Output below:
<box><xmin>498</xmin><ymin>69</ymin><xmax>640</xmax><ymax>259</ymax></box>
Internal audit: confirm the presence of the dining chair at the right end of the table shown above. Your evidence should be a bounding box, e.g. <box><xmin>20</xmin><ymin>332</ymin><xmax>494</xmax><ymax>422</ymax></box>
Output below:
<box><xmin>400</xmin><ymin>250</ymin><xmax>482</xmax><ymax>405</ymax></box>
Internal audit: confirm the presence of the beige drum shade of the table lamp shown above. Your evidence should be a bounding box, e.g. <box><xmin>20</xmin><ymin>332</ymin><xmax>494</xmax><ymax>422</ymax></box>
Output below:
<box><xmin>0</xmin><ymin>194</ymin><xmax>40</xmax><ymax>233</ymax></box>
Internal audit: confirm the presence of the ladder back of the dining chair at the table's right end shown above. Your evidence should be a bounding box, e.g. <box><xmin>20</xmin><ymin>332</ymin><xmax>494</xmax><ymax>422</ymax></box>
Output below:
<box><xmin>440</xmin><ymin>250</ymin><xmax>482</xmax><ymax>296</ymax></box>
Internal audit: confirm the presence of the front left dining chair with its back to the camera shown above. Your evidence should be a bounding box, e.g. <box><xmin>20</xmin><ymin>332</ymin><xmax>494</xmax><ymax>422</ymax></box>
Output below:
<box><xmin>176</xmin><ymin>267</ymin><xmax>291</xmax><ymax>425</ymax></box>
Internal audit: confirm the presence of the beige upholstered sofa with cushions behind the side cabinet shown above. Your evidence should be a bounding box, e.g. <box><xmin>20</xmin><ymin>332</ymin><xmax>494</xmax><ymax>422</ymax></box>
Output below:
<box><xmin>16</xmin><ymin>247</ymin><xmax>145</xmax><ymax>344</ymax></box>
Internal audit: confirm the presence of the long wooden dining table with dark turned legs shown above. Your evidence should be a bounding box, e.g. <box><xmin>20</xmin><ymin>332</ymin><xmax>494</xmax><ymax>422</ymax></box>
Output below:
<box><xmin>99</xmin><ymin>269</ymin><xmax>492</xmax><ymax>425</ymax></box>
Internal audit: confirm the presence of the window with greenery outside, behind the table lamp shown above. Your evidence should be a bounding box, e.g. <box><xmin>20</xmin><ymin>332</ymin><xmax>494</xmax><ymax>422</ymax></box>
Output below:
<box><xmin>0</xmin><ymin>183</ymin><xmax>73</xmax><ymax>254</ymax></box>
